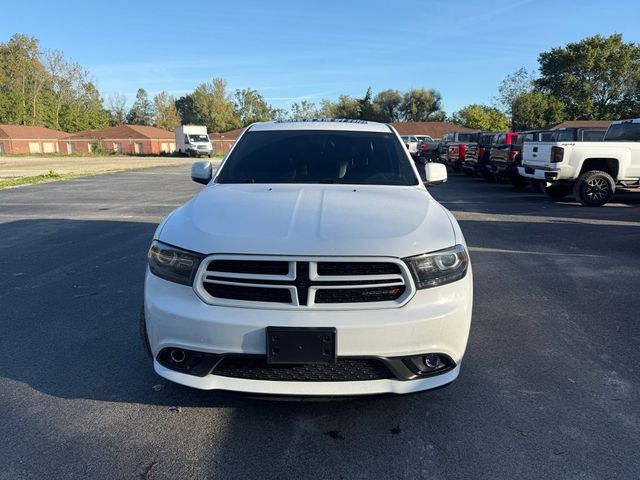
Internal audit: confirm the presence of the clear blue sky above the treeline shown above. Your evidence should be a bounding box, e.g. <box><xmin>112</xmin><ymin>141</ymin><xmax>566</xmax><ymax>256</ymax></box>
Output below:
<box><xmin>0</xmin><ymin>0</ymin><xmax>640</xmax><ymax>113</ymax></box>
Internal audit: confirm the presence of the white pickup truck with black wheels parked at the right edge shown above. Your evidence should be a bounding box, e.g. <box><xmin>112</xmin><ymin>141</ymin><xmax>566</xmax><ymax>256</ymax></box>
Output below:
<box><xmin>518</xmin><ymin>119</ymin><xmax>640</xmax><ymax>206</ymax></box>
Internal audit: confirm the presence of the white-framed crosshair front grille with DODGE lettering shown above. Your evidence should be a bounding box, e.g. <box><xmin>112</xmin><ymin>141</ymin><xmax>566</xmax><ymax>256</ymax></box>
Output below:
<box><xmin>194</xmin><ymin>255</ymin><xmax>413</xmax><ymax>309</ymax></box>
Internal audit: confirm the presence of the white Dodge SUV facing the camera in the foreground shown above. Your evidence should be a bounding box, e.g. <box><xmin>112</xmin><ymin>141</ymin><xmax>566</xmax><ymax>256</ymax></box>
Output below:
<box><xmin>141</xmin><ymin>120</ymin><xmax>473</xmax><ymax>396</ymax></box>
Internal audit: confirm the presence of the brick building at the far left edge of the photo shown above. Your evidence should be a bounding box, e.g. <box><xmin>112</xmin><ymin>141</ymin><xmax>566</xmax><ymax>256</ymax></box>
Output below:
<box><xmin>0</xmin><ymin>125</ymin><xmax>68</xmax><ymax>154</ymax></box>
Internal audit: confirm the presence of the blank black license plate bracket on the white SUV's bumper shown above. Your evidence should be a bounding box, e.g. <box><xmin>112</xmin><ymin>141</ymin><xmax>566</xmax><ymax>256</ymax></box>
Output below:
<box><xmin>266</xmin><ymin>327</ymin><xmax>337</xmax><ymax>364</ymax></box>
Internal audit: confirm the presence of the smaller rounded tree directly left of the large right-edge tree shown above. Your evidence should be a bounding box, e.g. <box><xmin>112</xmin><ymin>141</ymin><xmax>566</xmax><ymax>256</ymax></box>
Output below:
<box><xmin>511</xmin><ymin>92</ymin><xmax>567</xmax><ymax>131</ymax></box>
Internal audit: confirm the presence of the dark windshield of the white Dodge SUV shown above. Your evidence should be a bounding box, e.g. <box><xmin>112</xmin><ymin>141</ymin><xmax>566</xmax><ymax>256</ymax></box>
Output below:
<box><xmin>217</xmin><ymin>130</ymin><xmax>418</xmax><ymax>185</ymax></box>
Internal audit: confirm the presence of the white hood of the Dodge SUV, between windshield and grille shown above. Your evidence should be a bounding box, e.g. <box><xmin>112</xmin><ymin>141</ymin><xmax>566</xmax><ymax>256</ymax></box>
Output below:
<box><xmin>158</xmin><ymin>184</ymin><xmax>456</xmax><ymax>257</ymax></box>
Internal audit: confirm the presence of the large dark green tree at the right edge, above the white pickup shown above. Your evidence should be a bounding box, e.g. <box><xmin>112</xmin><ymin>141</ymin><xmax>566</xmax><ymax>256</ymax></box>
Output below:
<box><xmin>536</xmin><ymin>34</ymin><xmax>640</xmax><ymax>120</ymax></box>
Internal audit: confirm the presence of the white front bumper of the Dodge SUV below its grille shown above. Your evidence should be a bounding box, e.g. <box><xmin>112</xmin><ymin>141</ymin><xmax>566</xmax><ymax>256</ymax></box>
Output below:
<box><xmin>145</xmin><ymin>266</ymin><xmax>473</xmax><ymax>396</ymax></box>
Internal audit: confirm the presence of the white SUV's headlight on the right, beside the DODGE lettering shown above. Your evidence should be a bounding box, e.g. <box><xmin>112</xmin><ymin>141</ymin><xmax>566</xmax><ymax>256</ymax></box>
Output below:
<box><xmin>404</xmin><ymin>245</ymin><xmax>469</xmax><ymax>290</ymax></box>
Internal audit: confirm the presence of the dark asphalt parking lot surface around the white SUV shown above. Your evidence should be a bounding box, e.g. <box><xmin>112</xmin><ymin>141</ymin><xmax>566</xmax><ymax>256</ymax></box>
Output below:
<box><xmin>0</xmin><ymin>166</ymin><xmax>640</xmax><ymax>480</ymax></box>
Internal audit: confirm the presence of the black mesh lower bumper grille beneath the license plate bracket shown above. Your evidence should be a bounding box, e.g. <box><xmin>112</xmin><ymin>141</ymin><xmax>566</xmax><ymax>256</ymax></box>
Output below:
<box><xmin>212</xmin><ymin>357</ymin><xmax>395</xmax><ymax>382</ymax></box>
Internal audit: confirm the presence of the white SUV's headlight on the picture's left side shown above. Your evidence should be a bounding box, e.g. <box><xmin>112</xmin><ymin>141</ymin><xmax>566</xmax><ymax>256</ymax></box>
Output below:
<box><xmin>147</xmin><ymin>240</ymin><xmax>204</xmax><ymax>285</ymax></box>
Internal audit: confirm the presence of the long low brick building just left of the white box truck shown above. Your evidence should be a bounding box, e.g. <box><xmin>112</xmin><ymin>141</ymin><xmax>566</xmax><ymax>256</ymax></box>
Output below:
<box><xmin>65</xmin><ymin>125</ymin><xmax>176</xmax><ymax>155</ymax></box>
